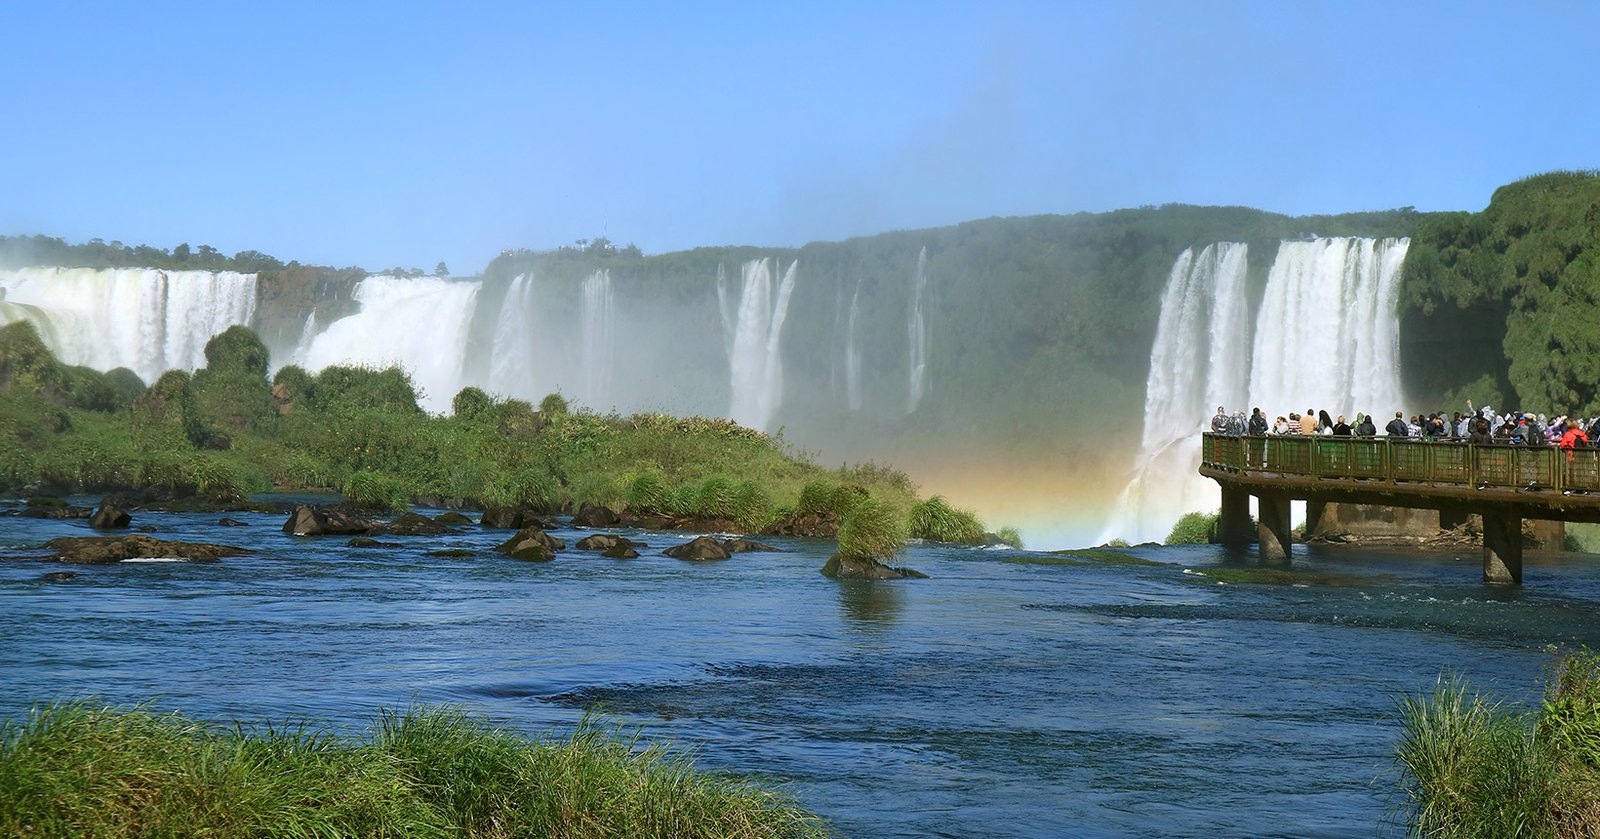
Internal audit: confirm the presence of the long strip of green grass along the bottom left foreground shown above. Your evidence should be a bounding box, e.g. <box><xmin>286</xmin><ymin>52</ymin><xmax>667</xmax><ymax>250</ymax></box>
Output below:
<box><xmin>0</xmin><ymin>705</ymin><xmax>829</xmax><ymax>839</ymax></box>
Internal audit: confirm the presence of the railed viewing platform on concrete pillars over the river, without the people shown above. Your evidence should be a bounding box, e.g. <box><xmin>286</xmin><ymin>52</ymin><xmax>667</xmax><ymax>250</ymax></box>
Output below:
<box><xmin>1200</xmin><ymin>432</ymin><xmax>1600</xmax><ymax>583</ymax></box>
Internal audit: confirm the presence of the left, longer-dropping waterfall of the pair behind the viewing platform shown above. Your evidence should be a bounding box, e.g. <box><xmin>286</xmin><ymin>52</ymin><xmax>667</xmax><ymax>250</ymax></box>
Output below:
<box><xmin>1101</xmin><ymin>242</ymin><xmax>1250</xmax><ymax>541</ymax></box>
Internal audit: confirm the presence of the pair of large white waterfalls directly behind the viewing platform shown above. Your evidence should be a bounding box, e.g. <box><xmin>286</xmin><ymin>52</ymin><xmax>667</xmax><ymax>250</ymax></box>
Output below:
<box><xmin>1101</xmin><ymin>239</ymin><xmax>1410</xmax><ymax>541</ymax></box>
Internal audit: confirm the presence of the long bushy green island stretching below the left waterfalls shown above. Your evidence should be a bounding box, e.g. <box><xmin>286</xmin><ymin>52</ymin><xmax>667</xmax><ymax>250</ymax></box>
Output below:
<box><xmin>0</xmin><ymin>320</ymin><xmax>1018</xmax><ymax>557</ymax></box>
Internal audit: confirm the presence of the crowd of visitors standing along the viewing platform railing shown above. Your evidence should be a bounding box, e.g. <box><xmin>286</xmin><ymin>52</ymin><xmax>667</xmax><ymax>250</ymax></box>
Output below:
<box><xmin>1211</xmin><ymin>400</ymin><xmax>1600</xmax><ymax>450</ymax></box>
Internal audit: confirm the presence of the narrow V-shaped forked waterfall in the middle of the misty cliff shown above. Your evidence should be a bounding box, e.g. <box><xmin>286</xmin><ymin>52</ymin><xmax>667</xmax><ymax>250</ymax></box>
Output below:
<box><xmin>717</xmin><ymin>259</ymin><xmax>800</xmax><ymax>431</ymax></box>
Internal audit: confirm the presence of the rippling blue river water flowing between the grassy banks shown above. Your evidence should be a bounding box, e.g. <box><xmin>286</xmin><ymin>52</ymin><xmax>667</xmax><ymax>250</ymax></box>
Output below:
<box><xmin>0</xmin><ymin>502</ymin><xmax>1600</xmax><ymax>837</ymax></box>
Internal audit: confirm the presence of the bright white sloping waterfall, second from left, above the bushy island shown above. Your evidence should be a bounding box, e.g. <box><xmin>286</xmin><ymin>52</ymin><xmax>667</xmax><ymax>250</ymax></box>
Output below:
<box><xmin>294</xmin><ymin>275</ymin><xmax>482</xmax><ymax>413</ymax></box>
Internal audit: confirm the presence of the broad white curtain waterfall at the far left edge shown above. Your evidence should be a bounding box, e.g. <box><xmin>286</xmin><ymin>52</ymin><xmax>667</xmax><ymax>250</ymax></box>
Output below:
<box><xmin>0</xmin><ymin>267</ymin><xmax>256</xmax><ymax>383</ymax></box>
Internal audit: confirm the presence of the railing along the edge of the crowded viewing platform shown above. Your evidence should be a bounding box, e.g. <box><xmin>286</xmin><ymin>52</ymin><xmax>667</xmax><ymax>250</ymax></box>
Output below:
<box><xmin>1200</xmin><ymin>432</ymin><xmax>1600</xmax><ymax>493</ymax></box>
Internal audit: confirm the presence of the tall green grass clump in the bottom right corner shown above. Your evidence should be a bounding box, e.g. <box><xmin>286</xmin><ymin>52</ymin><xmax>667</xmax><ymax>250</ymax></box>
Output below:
<box><xmin>1395</xmin><ymin>650</ymin><xmax>1600</xmax><ymax>839</ymax></box>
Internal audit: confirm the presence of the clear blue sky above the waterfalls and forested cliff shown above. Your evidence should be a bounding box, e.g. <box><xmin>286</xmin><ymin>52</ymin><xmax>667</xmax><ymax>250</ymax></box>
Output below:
<box><xmin>0</xmin><ymin>0</ymin><xmax>1600</xmax><ymax>274</ymax></box>
